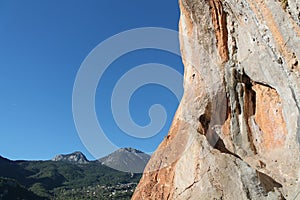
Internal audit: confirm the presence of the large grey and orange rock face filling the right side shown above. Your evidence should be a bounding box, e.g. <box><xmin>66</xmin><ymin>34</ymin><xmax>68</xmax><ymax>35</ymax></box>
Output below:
<box><xmin>132</xmin><ymin>0</ymin><xmax>300</xmax><ymax>200</ymax></box>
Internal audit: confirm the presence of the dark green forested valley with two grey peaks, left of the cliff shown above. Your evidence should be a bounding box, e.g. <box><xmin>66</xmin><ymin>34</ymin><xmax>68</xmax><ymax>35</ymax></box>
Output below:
<box><xmin>0</xmin><ymin>148</ymin><xmax>150</xmax><ymax>200</ymax></box>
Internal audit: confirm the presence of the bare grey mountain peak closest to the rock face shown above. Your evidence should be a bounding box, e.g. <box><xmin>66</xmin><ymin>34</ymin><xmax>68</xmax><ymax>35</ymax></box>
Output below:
<box><xmin>98</xmin><ymin>148</ymin><xmax>150</xmax><ymax>173</ymax></box>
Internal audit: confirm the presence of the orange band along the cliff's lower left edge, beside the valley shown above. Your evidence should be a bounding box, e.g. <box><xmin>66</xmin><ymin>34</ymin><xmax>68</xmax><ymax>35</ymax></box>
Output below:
<box><xmin>132</xmin><ymin>119</ymin><xmax>188</xmax><ymax>200</ymax></box>
